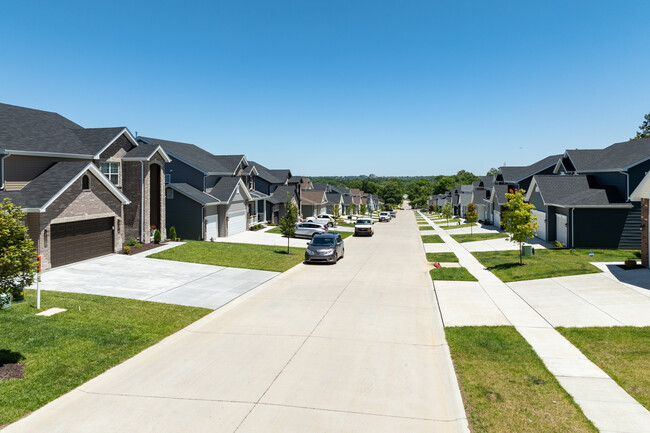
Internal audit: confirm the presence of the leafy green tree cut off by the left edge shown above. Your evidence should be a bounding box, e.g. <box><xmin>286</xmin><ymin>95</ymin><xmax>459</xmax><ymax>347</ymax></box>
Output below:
<box><xmin>0</xmin><ymin>198</ymin><xmax>37</xmax><ymax>296</ymax></box>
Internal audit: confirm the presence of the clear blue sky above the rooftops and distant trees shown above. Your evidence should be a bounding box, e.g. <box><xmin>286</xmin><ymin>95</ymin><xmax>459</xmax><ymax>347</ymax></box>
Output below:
<box><xmin>0</xmin><ymin>0</ymin><xmax>650</xmax><ymax>176</ymax></box>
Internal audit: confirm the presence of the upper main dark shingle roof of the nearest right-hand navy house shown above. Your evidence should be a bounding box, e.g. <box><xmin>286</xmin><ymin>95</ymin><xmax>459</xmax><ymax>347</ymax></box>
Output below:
<box><xmin>567</xmin><ymin>138</ymin><xmax>650</xmax><ymax>172</ymax></box>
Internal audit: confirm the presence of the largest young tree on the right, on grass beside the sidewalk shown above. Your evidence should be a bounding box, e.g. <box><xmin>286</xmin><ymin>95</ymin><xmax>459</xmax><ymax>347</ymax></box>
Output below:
<box><xmin>499</xmin><ymin>189</ymin><xmax>539</xmax><ymax>265</ymax></box>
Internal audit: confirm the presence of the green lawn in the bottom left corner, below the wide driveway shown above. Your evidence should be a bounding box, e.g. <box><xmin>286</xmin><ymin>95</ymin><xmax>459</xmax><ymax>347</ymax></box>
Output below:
<box><xmin>0</xmin><ymin>290</ymin><xmax>211</xmax><ymax>428</ymax></box>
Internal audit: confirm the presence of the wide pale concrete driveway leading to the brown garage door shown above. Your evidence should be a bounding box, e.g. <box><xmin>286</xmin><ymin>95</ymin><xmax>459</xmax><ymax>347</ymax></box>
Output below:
<box><xmin>31</xmin><ymin>243</ymin><xmax>278</xmax><ymax>309</ymax></box>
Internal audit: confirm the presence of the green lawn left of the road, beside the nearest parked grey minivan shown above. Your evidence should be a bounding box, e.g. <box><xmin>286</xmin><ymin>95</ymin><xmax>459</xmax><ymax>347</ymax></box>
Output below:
<box><xmin>149</xmin><ymin>240</ymin><xmax>306</xmax><ymax>272</ymax></box>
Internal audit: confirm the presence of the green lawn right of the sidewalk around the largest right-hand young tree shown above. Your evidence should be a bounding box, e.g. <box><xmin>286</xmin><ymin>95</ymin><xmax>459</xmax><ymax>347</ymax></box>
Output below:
<box><xmin>472</xmin><ymin>249</ymin><xmax>641</xmax><ymax>282</ymax></box>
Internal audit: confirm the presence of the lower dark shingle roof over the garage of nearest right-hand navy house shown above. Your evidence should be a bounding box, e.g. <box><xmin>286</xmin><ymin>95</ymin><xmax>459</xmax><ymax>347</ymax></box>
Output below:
<box><xmin>533</xmin><ymin>175</ymin><xmax>632</xmax><ymax>207</ymax></box>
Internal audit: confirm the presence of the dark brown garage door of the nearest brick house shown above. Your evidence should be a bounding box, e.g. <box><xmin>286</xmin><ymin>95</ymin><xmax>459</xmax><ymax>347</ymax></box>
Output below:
<box><xmin>50</xmin><ymin>218</ymin><xmax>113</xmax><ymax>267</ymax></box>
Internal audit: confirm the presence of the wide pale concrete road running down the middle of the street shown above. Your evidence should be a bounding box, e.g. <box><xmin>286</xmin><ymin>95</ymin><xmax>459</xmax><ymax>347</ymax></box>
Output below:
<box><xmin>3</xmin><ymin>211</ymin><xmax>469</xmax><ymax>433</ymax></box>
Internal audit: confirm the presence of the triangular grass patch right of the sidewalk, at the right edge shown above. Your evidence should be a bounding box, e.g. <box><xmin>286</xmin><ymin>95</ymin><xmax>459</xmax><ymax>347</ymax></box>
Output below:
<box><xmin>557</xmin><ymin>326</ymin><xmax>650</xmax><ymax>410</ymax></box>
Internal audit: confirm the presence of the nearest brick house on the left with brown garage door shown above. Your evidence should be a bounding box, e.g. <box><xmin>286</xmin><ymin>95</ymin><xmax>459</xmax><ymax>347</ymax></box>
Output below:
<box><xmin>0</xmin><ymin>104</ymin><xmax>170</xmax><ymax>269</ymax></box>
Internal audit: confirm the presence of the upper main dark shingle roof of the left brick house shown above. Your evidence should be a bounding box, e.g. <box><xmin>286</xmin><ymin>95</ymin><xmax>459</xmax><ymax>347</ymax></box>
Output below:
<box><xmin>0</xmin><ymin>104</ymin><xmax>126</xmax><ymax>156</ymax></box>
